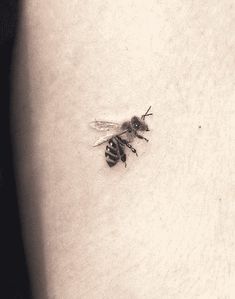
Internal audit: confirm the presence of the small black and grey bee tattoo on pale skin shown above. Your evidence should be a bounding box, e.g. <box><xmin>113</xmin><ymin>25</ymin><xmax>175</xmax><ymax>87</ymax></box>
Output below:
<box><xmin>90</xmin><ymin>106</ymin><xmax>153</xmax><ymax>167</ymax></box>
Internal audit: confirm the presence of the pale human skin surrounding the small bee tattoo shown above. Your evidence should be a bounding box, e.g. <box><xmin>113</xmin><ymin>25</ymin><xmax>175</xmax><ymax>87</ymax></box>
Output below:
<box><xmin>12</xmin><ymin>0</ymin><xmax>235</xmax><ymax>299</ymax></box>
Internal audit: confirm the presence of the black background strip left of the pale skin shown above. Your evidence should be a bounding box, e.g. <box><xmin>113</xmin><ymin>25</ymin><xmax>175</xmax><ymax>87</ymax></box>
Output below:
<box><xmin>0</xmin><ymin>0</ymin><xmax>32</xmax><ymax>299</ymax></box>
